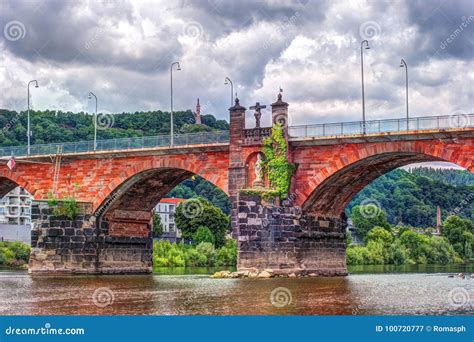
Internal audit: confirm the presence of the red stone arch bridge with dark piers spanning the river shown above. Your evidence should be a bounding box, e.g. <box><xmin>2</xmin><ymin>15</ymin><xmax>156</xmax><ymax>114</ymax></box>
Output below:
<box><xmin>0</xmin><ymin>95</ymin><xmax>474</xmax><ymax>275</ymax></box>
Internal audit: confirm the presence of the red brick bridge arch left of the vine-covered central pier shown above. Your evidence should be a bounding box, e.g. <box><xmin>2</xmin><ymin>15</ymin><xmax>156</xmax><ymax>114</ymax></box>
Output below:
<box><xmin>92</xmin><ymin>153</ymin><xmax>228</xmax><ymax>237</ymax></box>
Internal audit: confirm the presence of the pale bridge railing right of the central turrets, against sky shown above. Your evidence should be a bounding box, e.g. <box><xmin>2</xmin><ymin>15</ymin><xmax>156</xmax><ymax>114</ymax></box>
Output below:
<box><xmin>289</xmin><ymin>114</ymin><xmax>474</xmax><ymax>138</ymax></box>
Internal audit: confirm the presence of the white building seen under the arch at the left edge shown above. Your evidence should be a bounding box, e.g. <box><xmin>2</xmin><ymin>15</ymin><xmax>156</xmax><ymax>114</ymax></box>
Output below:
<box><xmin>0</xmin><ymin>187</ymin><xmax>33</xmax><ymax>243</ymax></box>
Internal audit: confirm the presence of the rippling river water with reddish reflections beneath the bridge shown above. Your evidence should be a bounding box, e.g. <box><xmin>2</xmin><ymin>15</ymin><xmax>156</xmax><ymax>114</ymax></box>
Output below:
<box><xmin>0</xmin><ymin>264</ymin><xmax>474</xmax><ymax>315</ymax></box>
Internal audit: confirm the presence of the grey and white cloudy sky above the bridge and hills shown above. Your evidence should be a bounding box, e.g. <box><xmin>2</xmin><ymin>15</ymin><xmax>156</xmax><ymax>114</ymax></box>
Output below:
<box><xmin>0</xmin><ymin>0</ymin><xmax>474</xmax><ymax>126</ymax></box>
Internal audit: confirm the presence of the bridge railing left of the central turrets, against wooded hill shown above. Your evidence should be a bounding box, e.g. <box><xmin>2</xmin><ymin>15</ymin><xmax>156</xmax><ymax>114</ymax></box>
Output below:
<box><xmin>0</xmin><ymin>131</ymin><xmax>229</xmax><ymax>157</ymax></box>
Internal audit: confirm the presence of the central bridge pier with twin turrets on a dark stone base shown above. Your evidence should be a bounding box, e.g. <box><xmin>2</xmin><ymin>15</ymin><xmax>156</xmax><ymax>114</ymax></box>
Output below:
<box><xmin>229</xmin><ymin>94</ymin><xmax>347</xmax><ymax>276</ymax></box>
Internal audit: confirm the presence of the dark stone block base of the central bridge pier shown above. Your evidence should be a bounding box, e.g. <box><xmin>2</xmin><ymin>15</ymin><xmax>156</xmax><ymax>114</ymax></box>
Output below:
<box><xmin>237</xmin><ymin>194</ymin><xmax>347</xmax><ymax>276</ymax></box>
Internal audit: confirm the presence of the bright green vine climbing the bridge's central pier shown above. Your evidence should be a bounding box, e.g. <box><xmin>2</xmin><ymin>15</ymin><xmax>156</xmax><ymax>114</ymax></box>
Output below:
<box><xmin>263</xmin><ymin>123</ymin><xmax>296</xmax><ymax>199</ymax></box>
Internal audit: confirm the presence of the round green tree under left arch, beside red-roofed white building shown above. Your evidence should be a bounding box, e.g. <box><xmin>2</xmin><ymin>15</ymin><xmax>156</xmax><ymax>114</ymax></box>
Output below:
<box><xmin>175</xmin><ymin>197</ymin><xmax>230</xmax><ymax>248</ymax></box>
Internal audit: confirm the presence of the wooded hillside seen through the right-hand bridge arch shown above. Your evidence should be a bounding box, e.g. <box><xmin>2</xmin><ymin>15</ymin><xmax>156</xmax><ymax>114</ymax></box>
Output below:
<box><xmin>346</xmin><ymin>168</ymin><xmax>474</xmax><ymax>227</ymax></box>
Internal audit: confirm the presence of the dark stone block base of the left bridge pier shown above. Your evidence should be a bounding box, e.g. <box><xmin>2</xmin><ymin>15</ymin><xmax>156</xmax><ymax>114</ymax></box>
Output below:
<box><xmin>29</xmin><ymin>202</ymin><xmax>152</xmax><ymax>274</ymax></box>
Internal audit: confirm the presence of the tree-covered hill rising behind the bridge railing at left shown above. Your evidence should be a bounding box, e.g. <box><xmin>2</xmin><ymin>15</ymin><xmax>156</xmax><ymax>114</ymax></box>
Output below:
<box><xmin>0</xmin><ymin>109</ymin><xmax>229</xmax><ymax>146</ymax></box>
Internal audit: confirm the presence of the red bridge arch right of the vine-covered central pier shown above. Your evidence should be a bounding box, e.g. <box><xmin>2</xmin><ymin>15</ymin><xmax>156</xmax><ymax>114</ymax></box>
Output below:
<box><xmin>297</xmin><ymin>141</ymin><xmax>474</xmax><ymax>217</ymax></box>
